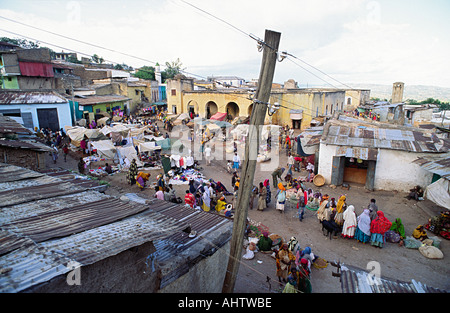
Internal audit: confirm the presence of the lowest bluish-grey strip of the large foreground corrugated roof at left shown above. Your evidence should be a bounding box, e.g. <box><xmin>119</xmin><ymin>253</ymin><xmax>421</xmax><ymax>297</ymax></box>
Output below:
<box><xmin>0</xmin><ymin>210</ymin><xmax>190</xmax><ymax>293</ymax></box>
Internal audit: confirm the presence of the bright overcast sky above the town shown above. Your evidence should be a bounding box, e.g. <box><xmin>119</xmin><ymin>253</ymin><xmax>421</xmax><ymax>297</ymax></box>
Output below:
<box><xmin>0</xmin><ymin>0</ymin><xmax>450</xmax><ymax>87</ymax></box>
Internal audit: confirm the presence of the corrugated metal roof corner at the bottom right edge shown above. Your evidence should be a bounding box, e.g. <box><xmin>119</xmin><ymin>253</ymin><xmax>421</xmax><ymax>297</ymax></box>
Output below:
<box><xmin>340</xmin><ymin>265</ymin><xmax>447</xmax><ymax>293</ymax></box>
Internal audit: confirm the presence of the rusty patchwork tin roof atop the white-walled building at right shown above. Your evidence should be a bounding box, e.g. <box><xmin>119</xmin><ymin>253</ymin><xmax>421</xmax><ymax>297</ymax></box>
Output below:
<box><xmin>321</xmin><ymin>115</ymin><xmax>448</xmax><ymax>153</ymax></box>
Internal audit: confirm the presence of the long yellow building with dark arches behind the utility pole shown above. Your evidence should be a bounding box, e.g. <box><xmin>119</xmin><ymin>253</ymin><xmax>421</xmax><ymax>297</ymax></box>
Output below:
<box><xmin>167</xmin><ymin>78</ymin><xmax>345</xmax><ymax>129</ymax></box>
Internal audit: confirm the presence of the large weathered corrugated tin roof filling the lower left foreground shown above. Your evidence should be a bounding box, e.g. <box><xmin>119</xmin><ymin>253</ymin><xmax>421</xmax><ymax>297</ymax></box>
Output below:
<box><xmin>0</xmin><ymin>163</ymin><xmax>232</xmax><ymax>292</ymax></box>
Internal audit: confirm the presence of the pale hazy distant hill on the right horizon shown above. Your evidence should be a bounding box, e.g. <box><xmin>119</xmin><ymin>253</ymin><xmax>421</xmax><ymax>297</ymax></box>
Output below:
<box><xmin>348</xmin><ymin>83</ymin><xmax>450</xmax><ymax>102</ymax></box>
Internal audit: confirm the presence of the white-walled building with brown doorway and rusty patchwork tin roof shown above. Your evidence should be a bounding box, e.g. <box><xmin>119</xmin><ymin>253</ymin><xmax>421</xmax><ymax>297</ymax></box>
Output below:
<box><xmin>318</xmin><ymin>114</ymin><xmax>450</xmax><ymax>192</ymax></box>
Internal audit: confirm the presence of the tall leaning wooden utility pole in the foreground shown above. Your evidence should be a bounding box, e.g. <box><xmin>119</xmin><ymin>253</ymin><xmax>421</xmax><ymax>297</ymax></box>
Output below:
<box><xmin>222</xmin><ymin>30</ymin><xmax>281</xmax><ymax>293</ymax></box>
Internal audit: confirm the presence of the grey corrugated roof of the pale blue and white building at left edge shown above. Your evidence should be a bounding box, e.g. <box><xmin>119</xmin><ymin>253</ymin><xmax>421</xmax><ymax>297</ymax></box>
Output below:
<box><xmin>0</xmin><ymin>90</ymin><xmax>68</xmax><ymax>105</ymax></box>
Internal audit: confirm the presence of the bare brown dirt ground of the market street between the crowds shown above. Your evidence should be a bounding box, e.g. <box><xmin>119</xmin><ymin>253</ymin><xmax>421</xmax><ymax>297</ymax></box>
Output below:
<box><xmin>47</xmin><ymin>127</ymin><xmax>450</xmax><ymax>293</ymax></box>
